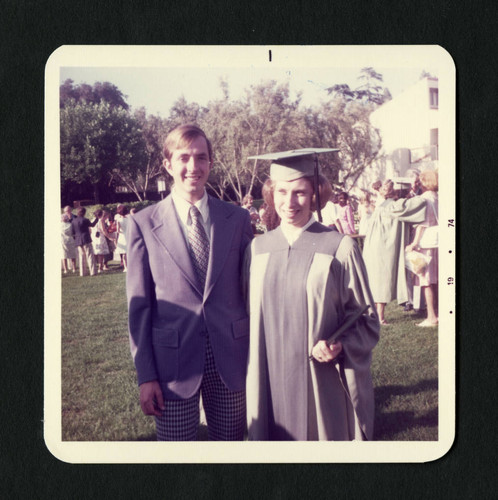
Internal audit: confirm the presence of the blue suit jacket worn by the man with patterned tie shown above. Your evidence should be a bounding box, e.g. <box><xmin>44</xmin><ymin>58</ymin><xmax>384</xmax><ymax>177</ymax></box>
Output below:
<box><xmin>126</xmin><ymin>196</ymin><xmax>253</xmax><ymax>399</ymax></box>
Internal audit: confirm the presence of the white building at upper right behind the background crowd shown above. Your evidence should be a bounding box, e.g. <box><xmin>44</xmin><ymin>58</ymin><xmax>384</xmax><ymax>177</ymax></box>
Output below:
<box><xmin>351</xmin><ymin>77</ymin><xmax>439</xmax><ymax>192</ymax></box>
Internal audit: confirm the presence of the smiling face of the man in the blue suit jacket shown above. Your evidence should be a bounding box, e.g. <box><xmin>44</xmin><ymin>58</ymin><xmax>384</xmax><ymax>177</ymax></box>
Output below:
<box><xmin>164</xmin><ymin>136</ymin><xmax>211</xmax><ymax>203</ymax></box>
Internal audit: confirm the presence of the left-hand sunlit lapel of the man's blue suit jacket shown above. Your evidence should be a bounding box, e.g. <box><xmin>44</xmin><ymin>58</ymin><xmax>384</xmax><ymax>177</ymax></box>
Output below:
<box><xmin>152</xmin><ymin>196</ymin><xmax>203</xmax><ymax>295</ymax></box>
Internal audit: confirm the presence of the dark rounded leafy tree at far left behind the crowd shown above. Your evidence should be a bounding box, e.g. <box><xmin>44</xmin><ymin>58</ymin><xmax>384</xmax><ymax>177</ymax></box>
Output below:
<box><xmin>60</xmin><ymin>99</ymin><xmax>145</xmax><ymax>203</ymax></box>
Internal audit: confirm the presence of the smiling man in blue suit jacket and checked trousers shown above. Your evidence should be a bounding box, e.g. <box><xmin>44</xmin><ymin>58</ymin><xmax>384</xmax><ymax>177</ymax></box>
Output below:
<box><xmin>127</xmin><ymin>125</ymin><xmax>252</xmax><ymax>441</ymax></box>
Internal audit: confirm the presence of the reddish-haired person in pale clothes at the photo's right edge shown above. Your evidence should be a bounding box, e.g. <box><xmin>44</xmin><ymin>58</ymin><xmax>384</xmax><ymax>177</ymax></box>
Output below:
<box><xmin>406</xmin><ymin>170</ymin><xmax>439</xmax><ymax>327</ymax></box>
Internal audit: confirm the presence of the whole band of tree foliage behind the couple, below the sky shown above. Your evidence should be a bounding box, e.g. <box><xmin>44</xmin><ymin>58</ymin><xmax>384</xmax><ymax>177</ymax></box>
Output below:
<box><xmin>60</xmin><ymin>67</ymin><xmax>390</xmax><ymax>201</ymax></box>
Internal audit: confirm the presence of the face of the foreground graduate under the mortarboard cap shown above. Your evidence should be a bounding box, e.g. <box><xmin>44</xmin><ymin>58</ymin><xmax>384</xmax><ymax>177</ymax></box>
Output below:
<box><xmin>273</xmin><ymin>178</ymin><xmax>313</xmax><ymax>227</ymax></box>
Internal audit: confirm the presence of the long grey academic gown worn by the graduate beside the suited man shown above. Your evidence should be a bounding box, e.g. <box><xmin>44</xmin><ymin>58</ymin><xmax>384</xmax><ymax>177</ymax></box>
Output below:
<box><xmin>246</xmin><ymin>223</ymin><xmax>379</xmax><ymax>440</ymax></box>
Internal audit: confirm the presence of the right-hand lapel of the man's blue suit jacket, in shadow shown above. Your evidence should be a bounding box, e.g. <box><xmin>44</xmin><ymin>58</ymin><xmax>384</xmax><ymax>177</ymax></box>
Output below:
<box><xmin>205</xmin><ymin>197</ymin><xmax>235</xmax><ymax>298</ymax></box>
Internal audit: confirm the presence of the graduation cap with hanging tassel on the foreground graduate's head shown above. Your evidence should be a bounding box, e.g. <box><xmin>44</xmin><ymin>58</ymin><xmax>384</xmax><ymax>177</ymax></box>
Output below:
<box><xmin>248</xmin><ymin>148</ymin><xmax>339</xmax><ymax>222</ymax></box>
